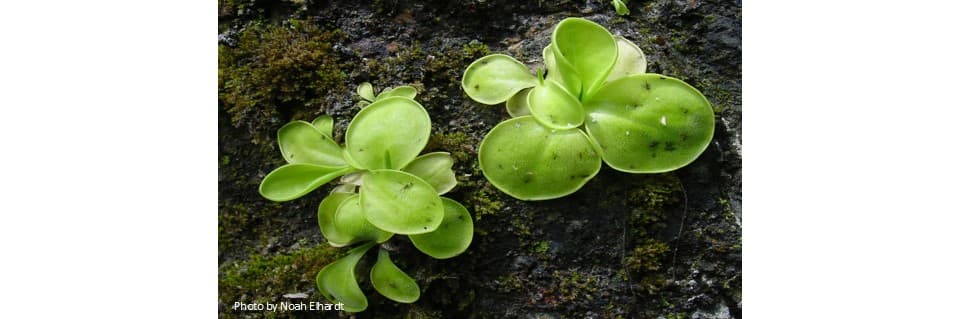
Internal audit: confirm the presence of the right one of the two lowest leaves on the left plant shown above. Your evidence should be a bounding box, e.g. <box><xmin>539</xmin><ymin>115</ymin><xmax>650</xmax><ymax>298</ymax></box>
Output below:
<box><xmin>370</xmin><ymin>248</ymin><xmax>420</xmax><ymax>303</ymax></box>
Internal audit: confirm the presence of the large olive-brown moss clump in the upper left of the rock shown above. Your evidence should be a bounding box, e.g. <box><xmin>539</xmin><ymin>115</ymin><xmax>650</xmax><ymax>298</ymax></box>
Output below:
<box><xmin>219</xmin><ymin>20</ymin><xmax>346</xmax><ymax>143</ymax></box>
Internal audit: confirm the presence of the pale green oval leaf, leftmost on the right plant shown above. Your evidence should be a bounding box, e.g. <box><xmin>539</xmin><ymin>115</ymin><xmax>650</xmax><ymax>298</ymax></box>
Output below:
<box><xmin>461</xmin><ymin>54</ymin><xmax>537</xmax><ymax>105</ymax></box>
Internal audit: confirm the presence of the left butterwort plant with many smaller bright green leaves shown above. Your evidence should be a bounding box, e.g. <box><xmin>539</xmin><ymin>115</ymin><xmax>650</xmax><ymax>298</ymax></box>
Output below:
<box><xmin>260</xmin><ymin>83</ymin><xmax>473</xmax><ymax>312</ymax></box>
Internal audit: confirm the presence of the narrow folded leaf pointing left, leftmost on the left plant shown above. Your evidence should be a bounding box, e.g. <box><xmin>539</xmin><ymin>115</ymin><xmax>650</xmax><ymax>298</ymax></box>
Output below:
<box><xmin>260</xmin><ymin>164</ymin><xmax>353</xmax><ymax>202</ymax></box>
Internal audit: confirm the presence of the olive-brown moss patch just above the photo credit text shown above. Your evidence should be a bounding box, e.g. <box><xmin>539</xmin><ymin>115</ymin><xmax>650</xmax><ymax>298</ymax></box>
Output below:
<box><xmin>219</xmin><ymin>245</ymin><xmax>344</xmax><ymax>306</ymax></box>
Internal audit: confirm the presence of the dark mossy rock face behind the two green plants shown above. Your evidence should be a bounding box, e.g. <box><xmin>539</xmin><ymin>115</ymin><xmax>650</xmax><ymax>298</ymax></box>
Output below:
<box><xmin>218</xmin><ymin>0</ymin><xmax>742</xmax><ymax>319</ymax></box>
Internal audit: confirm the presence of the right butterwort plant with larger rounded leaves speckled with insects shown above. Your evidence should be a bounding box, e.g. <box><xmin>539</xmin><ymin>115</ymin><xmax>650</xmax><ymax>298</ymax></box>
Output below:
<box><xmin>461</xmin><ymin>18</ymin><xmax>714</xmax><ymax>200</ymax></box>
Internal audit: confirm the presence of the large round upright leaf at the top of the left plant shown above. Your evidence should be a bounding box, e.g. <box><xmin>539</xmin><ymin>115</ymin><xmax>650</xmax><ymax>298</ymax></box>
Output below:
<box><xmin>344</xmin><ymin>97</ymin><xmax>430</xmax><ymax>170</ymax></box>
